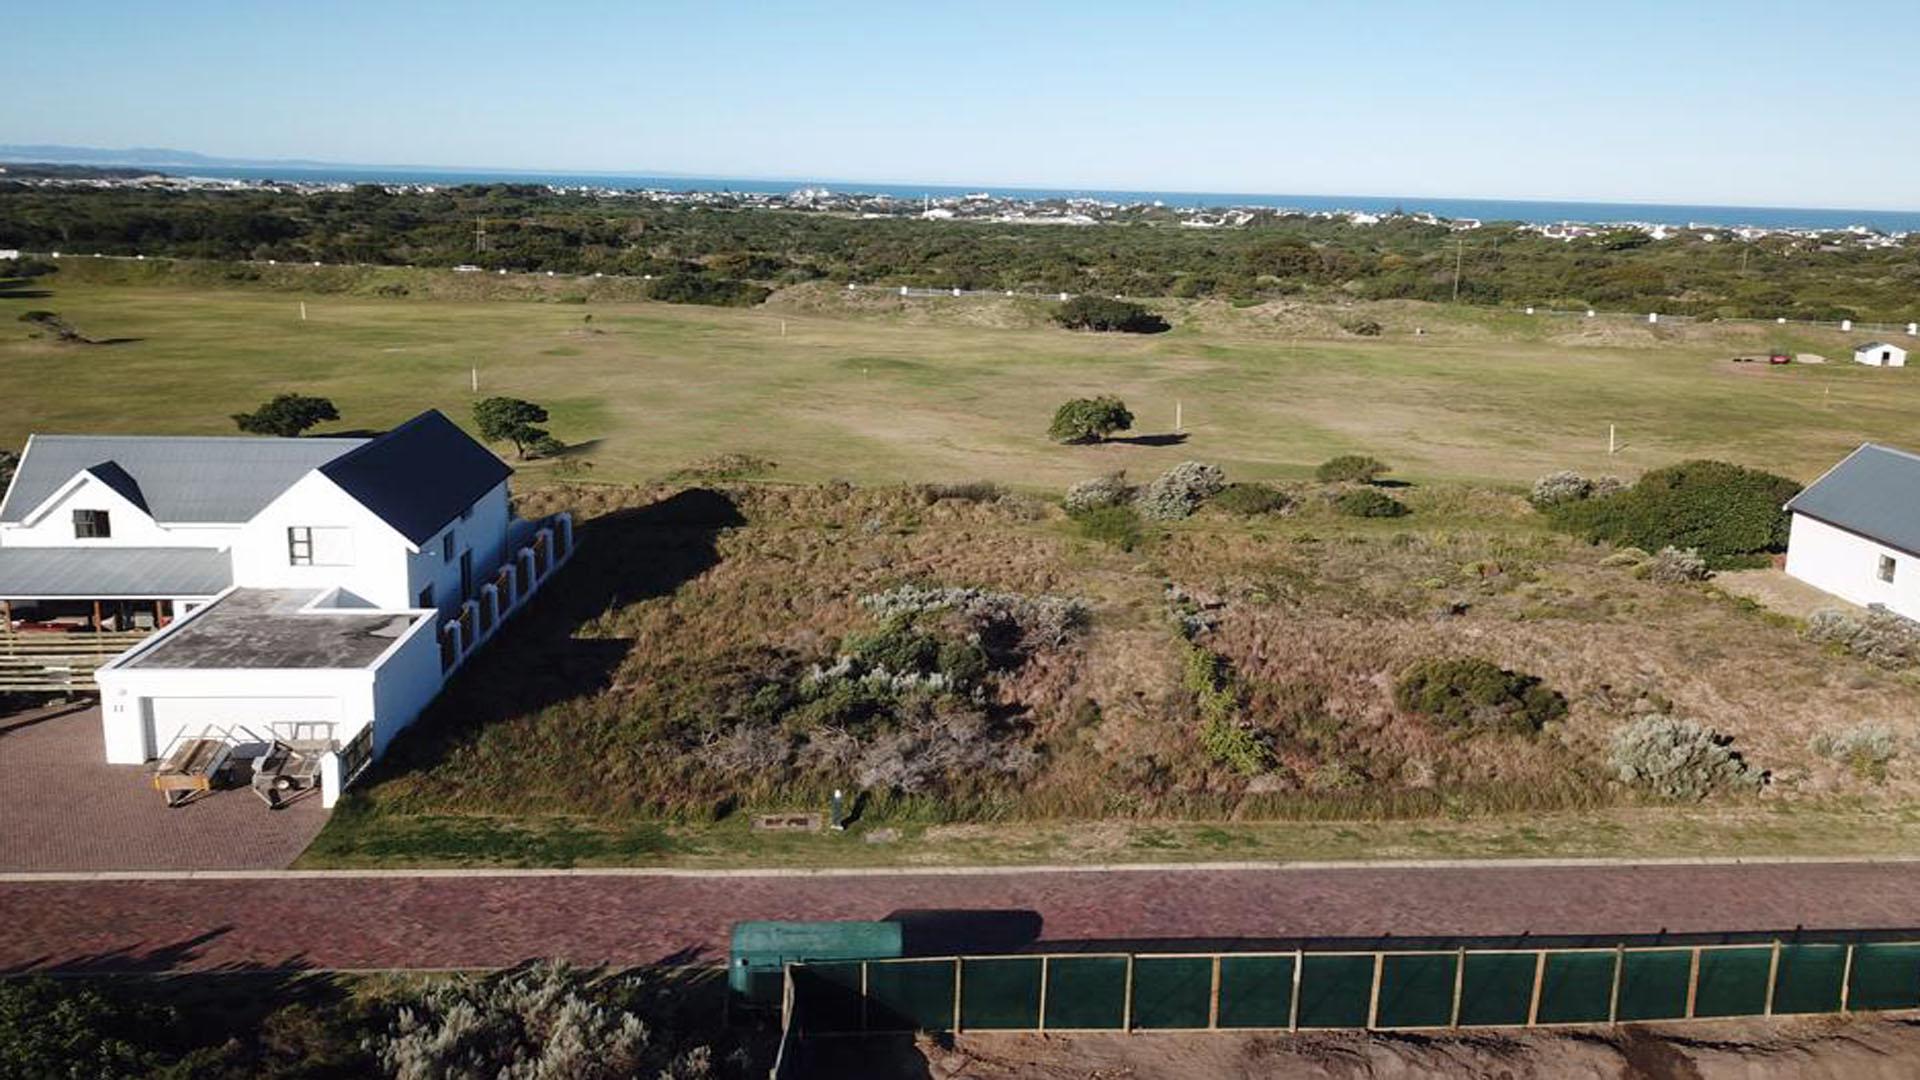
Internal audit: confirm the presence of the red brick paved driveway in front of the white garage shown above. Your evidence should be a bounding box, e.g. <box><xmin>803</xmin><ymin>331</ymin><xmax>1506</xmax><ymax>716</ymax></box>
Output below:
<box><xmin>0</xmin><ymin>707</ymin><xmax>326</xmax><ymax>871</ymax></box>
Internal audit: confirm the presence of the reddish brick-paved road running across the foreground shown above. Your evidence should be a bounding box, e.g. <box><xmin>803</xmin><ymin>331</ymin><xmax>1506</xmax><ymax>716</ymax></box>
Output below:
<box><xmin>0</xmin><ymin>863</ymin><xmax>1920</xmax><ymax>972</ymax></box>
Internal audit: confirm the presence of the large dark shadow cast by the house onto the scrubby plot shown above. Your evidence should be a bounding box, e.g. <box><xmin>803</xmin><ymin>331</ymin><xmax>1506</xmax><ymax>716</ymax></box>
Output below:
<box><xmin>374</xmin><ymin>488</ymin><xmax>747</xmax><ymax>780</ymax></box>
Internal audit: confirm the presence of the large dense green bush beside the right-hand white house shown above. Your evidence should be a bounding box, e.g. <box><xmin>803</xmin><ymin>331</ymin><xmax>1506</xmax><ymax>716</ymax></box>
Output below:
<box><xmin>1546</xmin><ymin>461</ymin><xmax>1801</xmax><ymax>569</ymax></box>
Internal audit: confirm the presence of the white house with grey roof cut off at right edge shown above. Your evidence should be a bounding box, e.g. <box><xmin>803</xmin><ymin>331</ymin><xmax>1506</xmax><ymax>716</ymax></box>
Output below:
<box><xmin>1786</xmin><ymin>444</ymin><xmax>1920</xmax><ymax>619</ymax></box>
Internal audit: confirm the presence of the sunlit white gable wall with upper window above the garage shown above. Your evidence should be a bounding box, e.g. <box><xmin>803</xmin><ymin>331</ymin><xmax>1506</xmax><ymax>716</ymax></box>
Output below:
<box><xmin>234</xmin><ymin>473</ymin><xmax>413</xmax><ymax>609</ymax></box>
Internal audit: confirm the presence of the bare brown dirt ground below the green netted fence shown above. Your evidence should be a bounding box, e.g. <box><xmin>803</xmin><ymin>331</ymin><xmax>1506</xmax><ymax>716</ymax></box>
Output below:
<box><xmin>803</xmin><ymin>1015</ymin><xmax>1920</xmax><ymax>1080</ymax></box>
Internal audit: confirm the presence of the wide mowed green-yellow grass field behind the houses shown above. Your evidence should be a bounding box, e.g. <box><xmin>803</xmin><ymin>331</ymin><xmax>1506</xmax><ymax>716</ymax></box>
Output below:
<box><xmin>0</xmin><ymin>275</ymin><xmax>1920</xmax><ymax>488</ymax></box>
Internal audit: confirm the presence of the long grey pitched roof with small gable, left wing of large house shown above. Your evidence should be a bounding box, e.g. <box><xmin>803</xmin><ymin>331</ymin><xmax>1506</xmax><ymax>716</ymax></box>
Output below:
<box><xmin>0</xmin><ymin>434</ymin><xmax>367</xmax><ymax>525</ymax></box>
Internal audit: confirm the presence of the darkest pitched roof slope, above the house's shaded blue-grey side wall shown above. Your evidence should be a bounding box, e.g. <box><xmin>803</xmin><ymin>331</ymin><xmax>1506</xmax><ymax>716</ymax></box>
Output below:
<box><xmin>321</xmin><ymin>409</ymin><xmax>513</xmax><ymax>546</ymax></box>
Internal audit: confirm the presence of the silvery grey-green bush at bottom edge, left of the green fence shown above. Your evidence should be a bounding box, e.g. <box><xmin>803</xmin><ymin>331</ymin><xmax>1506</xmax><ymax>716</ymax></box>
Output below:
<box><xmin>372</xmin><ymin>965</ymin><xmax>712</xmax><ymax>1080</ymax></box>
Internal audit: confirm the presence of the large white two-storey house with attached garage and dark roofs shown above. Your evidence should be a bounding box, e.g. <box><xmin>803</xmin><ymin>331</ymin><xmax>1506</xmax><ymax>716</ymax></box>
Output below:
<box><xmin>0</xmin><ymin>411</ymin><xmax>572</xmax><ymax>803</ymax></box>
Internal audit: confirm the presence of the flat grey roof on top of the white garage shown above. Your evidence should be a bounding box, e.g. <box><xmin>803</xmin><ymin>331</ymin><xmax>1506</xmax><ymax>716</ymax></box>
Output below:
<box><xmin>121</xmin><ymin>588</ymin><xmax>432</xmax><ymax>669</ymax></box>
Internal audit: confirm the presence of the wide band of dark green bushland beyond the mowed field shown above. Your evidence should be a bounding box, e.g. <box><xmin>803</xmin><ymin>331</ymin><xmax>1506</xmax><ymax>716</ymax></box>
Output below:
<box><xmin>0</xmin><ymin>184</ymin><xmax>1920</xmax><ymax>319</ymax></box>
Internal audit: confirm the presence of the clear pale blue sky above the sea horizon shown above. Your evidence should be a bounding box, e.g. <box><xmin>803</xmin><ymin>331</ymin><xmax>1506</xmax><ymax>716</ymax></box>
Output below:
<box><xmin>0</xmin><ymin>0</ymin><xmax>1920</xmax><ymax>209</ymax></box>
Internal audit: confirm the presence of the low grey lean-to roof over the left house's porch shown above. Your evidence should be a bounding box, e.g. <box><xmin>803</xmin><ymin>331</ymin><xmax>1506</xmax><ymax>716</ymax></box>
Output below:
<box><xmin>0</xmin><ymin>548</ymin><xmax>234</xmax><ymax>600</ymax></box>
